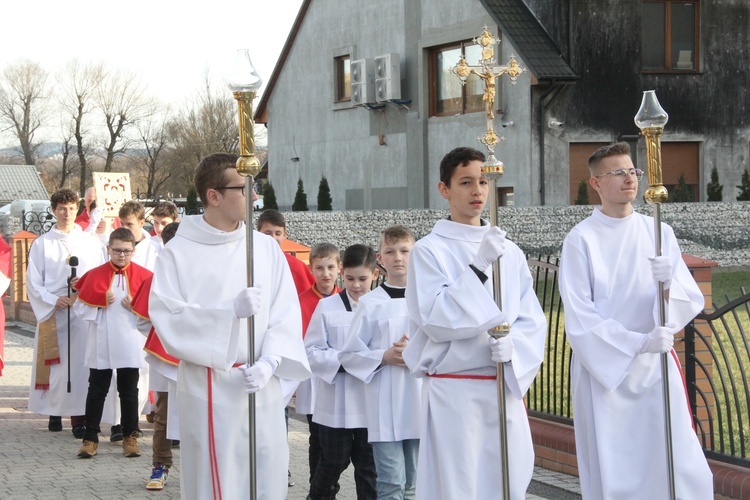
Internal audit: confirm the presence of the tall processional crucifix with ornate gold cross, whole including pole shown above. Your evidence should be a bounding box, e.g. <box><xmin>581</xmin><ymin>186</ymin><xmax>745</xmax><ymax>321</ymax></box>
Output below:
<box><xmin>451</xmin><ymin>26</ymin><xmax>525</xmax><ymax>500</ymax></box>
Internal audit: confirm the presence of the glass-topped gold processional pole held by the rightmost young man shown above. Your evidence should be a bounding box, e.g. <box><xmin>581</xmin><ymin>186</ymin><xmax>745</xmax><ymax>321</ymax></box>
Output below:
<box><xmin>635</xmin><ymin>90</ymin><xmax>675</xmax><ymax>500</ymax></box>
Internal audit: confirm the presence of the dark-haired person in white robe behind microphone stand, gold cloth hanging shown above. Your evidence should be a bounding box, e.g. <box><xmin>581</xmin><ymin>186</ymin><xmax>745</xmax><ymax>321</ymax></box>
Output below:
<box><xmin>26</xmin><ymin>189</ymin><xmax>104</xmax><ymax>437</ymax></box>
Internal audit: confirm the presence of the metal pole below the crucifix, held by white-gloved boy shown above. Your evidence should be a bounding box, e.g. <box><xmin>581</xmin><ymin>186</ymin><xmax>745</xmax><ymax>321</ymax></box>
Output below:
<box><xmin>482</xmin><ymin>162</ymin><xmax>510</xmax><ymax>500</ymax></box>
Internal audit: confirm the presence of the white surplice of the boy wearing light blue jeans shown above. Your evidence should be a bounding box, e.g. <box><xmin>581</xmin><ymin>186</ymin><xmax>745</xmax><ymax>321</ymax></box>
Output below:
<box><xmin>339</xmin><ymin>285</ymin><xmax>422</xmax><ymax>443</ymax></box>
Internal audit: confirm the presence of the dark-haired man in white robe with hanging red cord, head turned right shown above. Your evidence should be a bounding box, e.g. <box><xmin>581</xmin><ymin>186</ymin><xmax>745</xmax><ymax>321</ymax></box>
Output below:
<box><xmin>149</xmin><ymin>153</ymin><xmax>310</xmax><ymax>500</ymax></box>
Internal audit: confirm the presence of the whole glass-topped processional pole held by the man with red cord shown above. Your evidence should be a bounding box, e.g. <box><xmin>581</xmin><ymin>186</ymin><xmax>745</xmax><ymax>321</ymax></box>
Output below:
<box><xmin>228</xmin><ymin>49</ymin><xmax>263</xmax><ymax>500</ymax></box>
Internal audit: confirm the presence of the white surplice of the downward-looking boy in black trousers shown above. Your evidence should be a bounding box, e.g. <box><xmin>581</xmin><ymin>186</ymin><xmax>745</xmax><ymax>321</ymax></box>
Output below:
<box><xmin>305</xmin><ymin>293</ymin><xmax>367</xmax><ymax>429</ymax></box>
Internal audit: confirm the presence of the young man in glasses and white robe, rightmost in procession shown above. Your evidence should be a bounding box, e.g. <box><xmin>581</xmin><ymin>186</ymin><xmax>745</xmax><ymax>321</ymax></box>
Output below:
<box><xmin>560</xmin><ymin>142</ymin><xmax>713</xmax><ymax>499</ymax></box>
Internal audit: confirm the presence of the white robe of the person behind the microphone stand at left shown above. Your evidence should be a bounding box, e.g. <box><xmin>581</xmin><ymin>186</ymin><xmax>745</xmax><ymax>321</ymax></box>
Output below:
<box><xmin>26</xmin><ymin>225</ymin><xmax>104</xmax><ymax>416</ymax></box>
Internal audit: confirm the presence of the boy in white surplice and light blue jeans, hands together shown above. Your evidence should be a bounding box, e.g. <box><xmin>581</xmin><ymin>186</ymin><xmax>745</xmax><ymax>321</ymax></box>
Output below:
<box><xmin>339</xmin><ymin>226</ymin><xmax>422</xmax><ymax>500</ymax></box>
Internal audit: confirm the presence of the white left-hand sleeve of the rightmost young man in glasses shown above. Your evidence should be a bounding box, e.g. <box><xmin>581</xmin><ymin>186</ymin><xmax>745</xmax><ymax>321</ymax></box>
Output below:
<box><xmin>559</xmin><ymin>230</ymin><xmax>643</xmax><ymax>390</ymax></box>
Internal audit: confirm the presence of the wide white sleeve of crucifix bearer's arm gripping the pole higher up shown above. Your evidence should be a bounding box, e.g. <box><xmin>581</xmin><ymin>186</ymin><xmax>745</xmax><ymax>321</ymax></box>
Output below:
<box><xmin>406</xmin><ymin>239</ymin><xmax>503</xmax><ymax>342</ymax></box>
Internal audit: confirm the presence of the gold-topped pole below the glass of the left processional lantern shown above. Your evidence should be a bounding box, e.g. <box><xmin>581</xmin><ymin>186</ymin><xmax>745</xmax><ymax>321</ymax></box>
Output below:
<box><xmin>233</xmin><ymin>91</ymin><xmax>260</xmax><ymax>500</ymax></box>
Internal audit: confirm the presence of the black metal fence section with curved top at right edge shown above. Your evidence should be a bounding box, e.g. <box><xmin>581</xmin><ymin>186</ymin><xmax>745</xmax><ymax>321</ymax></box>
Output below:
<box><xmin>685</xmin><ymin>288</ymin><xmax>750</xmax><ymax>467</ymax></box>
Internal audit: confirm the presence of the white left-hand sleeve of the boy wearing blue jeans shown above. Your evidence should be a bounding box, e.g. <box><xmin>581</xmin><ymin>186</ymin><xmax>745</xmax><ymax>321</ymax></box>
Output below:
<box><xmin>339</xmin><ymin>300</ymin><xmax>385</xmax><ymax>384</ymax></box>
